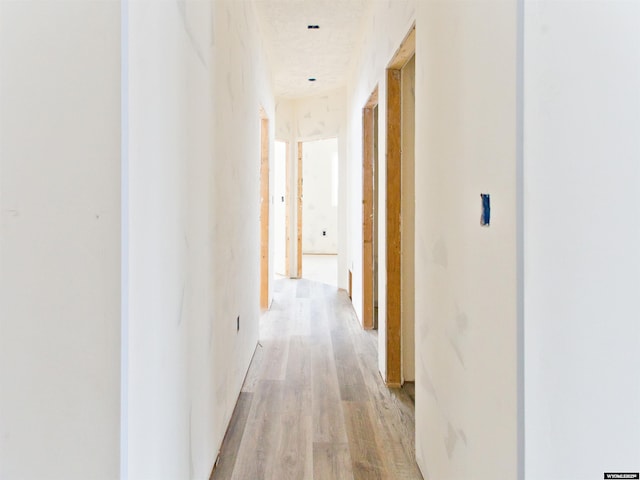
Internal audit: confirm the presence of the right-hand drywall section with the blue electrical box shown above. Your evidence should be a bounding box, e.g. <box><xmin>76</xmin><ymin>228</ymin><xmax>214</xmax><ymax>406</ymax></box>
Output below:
<box><xmin>415</xmin><ymin>0</ymin><xmax>518</xmax><ymax>480</ymax></box>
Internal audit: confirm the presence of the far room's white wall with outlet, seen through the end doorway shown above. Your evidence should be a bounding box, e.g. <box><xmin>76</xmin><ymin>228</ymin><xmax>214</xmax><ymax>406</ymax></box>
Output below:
<box><xmin>302</xmin><ymin>138</ymin><xmax>338</xmax><ymax>253</ymax></box>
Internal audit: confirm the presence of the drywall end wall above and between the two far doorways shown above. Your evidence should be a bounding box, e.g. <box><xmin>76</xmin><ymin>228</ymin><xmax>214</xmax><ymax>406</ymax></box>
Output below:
<box><xmin>276</xmin><ymin>89</ymin><xmax>348</xmax><ymax>289</ymax></box>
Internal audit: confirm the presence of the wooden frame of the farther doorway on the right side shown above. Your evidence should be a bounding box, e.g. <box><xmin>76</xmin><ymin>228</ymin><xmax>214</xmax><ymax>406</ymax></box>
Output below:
<box><xmin>362</xmin><ymin>86</ymin><xmax>378</xmax><ymax>330</ymax></box>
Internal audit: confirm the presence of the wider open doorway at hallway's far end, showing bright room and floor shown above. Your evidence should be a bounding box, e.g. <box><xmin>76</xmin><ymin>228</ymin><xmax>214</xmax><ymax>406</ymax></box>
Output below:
<box><xmin>298</xmin><ymin>138</ymin><xmax>339</xmax><ymax>286</ymax></box>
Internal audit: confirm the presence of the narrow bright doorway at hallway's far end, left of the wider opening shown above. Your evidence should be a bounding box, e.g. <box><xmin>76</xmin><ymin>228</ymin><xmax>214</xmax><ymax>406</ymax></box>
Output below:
<box><xmin>273</xmin><ymin>140</ymin><xmax>289</xmax><ymax>278</ymax></box>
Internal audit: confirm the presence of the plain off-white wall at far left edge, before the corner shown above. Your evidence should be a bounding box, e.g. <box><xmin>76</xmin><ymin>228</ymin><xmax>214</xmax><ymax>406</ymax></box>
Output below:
<box><xmin>0</xmin><ymin>1</ymin><xmax>121</xmax><ymax>480</ymax></box>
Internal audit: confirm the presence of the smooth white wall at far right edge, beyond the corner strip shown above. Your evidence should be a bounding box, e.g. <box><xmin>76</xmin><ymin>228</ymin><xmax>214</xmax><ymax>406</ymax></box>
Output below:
<box><xmin>524</xmin><ymin>1</ymin><xmax>640</xmax><ymax>480</ymax></box>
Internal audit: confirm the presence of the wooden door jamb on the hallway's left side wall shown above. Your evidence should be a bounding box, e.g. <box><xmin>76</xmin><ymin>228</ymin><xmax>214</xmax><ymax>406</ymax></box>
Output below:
<box><xmin>260</xmin><ymin>113</ymin><xmax>269</xmax><ymax>310</ymax></box>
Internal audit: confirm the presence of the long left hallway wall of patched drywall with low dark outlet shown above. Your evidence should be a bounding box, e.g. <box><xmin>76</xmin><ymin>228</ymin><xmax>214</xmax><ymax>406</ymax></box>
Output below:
<box><xmin>128</xmin><ymin>0</ymin><xmax>274</xmax><ymax>480</ymax></box>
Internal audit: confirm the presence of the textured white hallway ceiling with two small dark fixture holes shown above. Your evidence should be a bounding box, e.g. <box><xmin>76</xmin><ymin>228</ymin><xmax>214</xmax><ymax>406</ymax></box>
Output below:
<box><xmin>250</xmin><ymin>0</ymin><xmax>371</xmax><ymax>98</ymax></box>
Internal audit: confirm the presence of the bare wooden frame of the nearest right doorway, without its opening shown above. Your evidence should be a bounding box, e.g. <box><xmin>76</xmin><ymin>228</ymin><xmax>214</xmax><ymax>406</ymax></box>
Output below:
<box><xmin>385</xmin><ymin>25</ymin><xmax>416</xmax><ymax>387</ymax></box>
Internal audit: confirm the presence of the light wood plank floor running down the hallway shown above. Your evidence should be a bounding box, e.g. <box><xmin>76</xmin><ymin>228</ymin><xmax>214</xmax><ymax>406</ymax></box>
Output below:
<box><xmin>211</xmin><ymin>279</ymin><xmax>422</xmax><ymax>480</ymax></box>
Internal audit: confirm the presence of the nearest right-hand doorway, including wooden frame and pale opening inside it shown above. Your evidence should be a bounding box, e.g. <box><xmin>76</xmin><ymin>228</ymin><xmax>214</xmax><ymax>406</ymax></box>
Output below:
<box><xmin>386</xmin><ymin>27</ymin><xmax>415</xmax><ymax>387</ymax></box>
